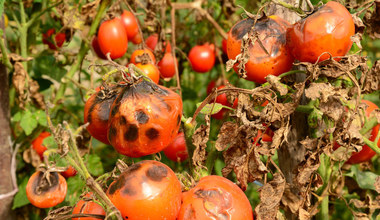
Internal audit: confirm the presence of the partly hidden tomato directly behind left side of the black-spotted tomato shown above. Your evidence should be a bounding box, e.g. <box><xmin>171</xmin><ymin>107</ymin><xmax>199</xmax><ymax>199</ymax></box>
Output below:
<box><xmin>84</xmin><ymin>86</ymin><xmax>120</xmax><ymax>144</ymax></box>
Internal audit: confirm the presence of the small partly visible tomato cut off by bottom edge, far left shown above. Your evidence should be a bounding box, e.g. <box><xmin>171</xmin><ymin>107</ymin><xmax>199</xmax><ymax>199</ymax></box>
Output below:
<box><xmin>72</xmin><ymin>193</ymin><xmax>106</xmax><ymax>220</ymax></box>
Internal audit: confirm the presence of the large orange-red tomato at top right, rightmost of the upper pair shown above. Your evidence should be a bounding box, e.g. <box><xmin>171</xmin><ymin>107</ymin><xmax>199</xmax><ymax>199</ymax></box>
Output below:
<box><xmin>287</xmin><ymin>1</ymin><xmax>355</xmax><ymax>63</ymax></box>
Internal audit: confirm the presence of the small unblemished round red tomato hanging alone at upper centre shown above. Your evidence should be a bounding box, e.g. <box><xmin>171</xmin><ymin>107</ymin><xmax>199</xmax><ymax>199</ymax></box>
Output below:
<box><xmin>188</xmin><ymin>43</ymin><xmax>215</xmax><ymax>73</ymax></box>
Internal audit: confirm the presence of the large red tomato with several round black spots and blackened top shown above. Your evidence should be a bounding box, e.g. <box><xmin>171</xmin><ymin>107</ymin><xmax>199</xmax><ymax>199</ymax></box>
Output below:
<box><xmin>108</xmin><ymin>80</ymin><xmax>182</xmax><ymax>157</ymax></box>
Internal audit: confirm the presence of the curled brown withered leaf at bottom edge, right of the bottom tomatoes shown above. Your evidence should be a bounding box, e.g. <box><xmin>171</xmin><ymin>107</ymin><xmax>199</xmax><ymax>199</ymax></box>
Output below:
<box><xmin>255</xmin><ymin>173</ymin><xmax>286</xmax><ymax>220</ymax></box>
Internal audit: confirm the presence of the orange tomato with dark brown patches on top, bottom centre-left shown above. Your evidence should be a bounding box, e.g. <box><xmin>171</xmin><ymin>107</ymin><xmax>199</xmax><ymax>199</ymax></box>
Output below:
<box><xmin>107</xmin><ymin>160</ymin><xmax>181</xmax><ymax>220</ymax></box>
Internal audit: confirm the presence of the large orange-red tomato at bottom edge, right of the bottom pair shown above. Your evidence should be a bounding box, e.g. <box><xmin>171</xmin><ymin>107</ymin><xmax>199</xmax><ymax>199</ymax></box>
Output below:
<box><xmin>177</xmin><ymin>176</ymin><xmax>253</xmax><ymax>220</ymax></box>
